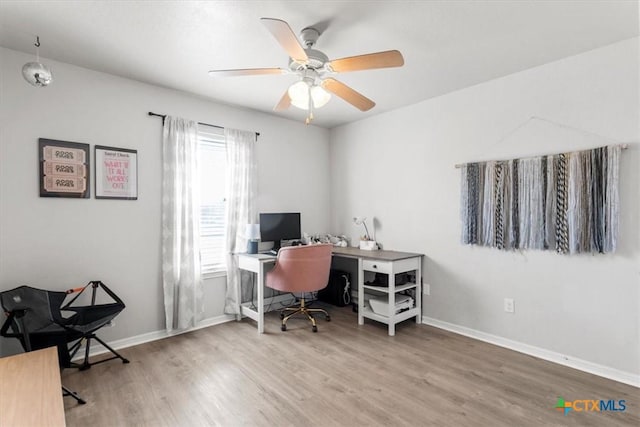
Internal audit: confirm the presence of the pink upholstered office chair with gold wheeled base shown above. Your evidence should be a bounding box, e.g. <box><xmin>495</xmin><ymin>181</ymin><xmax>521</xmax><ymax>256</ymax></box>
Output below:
<box><xmin>267</xmin><ymin>245</ymin><xmax>332</xmax><ymax>332</ymax></box>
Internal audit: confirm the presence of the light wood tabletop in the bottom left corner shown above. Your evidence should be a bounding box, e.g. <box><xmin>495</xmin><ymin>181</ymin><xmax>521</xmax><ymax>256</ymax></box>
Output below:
<box><xmin>0</xmin><ymin>347</ymin><xmax>66</xmax><ymax>427</ymax></box>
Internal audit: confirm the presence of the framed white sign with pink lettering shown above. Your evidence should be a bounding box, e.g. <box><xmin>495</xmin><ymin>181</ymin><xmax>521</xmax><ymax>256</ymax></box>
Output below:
<box><xmin>95</xmin><ymin>145</ymin><xmax>138</xmax><ymax>200</ymax></box>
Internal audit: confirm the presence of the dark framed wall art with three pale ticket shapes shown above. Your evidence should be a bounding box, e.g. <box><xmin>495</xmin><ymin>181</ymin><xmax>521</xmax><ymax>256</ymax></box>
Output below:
<box><xmin>38</xmin><ymin>138</ymin><xmax>90</xmax><ymax>199</ymax></box>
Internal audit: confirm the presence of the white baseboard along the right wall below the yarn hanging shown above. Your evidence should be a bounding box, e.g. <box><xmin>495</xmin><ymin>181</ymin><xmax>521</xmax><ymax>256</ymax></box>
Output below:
<box><xmin>422</xmin><ymin>316</ymin><xmax>640</xmax><ymax>388</ymax></box>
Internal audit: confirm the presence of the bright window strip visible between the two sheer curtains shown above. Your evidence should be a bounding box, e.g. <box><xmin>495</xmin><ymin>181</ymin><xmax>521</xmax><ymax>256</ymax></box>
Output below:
<box><xmin>198</xmin><ymin>126</ymin><xmax>227</xmax><ymax>275</ymax></box>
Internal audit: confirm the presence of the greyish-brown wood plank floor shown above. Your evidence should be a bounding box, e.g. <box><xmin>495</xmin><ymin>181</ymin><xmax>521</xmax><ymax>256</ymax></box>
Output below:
<box><xmin>62</xmin><ymin>307</ymin><xmax>640</xmax><ymax>427</ymax></box>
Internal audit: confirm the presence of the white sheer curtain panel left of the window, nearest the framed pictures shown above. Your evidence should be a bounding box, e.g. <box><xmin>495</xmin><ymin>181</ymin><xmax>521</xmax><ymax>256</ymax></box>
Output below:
<box><xmin>162</xmin><ymin>116</ymin><xmax>204</xmax><ymax>332</ymax></box>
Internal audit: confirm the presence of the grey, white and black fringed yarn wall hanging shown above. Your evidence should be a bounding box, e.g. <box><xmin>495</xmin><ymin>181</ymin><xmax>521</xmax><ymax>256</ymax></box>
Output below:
<box><xmin>460</xmin><ymin>145</ymin><xmax>626</xmax><ymax>254</ymax></box>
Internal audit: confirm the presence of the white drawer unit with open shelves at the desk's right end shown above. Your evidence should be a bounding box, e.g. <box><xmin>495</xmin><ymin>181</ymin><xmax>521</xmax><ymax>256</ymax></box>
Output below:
<box><xmin>358</xmin><ymin>255</ymin><xmax>422</xmax><ymax>336</ymax></box>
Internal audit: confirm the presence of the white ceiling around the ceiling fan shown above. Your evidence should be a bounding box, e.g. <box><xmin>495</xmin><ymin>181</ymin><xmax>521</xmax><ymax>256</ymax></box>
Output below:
<box><xmin>0</xmin><ymin>0</ymin><xmax>639</xmax><ymax>127</ymax></box>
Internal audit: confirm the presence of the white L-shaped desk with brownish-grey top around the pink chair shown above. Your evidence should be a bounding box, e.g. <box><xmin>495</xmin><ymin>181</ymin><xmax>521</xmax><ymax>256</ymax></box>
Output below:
<box><xmin>238</xmin><ymin>247</ymin><xmax>423</xmax><ymax>336</ymax></box>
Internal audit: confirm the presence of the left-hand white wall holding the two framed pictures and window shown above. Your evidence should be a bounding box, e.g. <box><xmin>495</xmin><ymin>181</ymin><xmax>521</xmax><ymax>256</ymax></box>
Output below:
<box><xmin>0</xmin><ymin>49</ymin><xmax>329</xmax><ymax>353</ymax></box>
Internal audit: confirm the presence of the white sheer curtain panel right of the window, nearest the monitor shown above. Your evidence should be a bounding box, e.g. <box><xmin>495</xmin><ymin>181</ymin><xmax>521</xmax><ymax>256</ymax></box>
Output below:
<box><xmin>224</xmin><ymin>129</ymin><xmax>257</xmax><ymax>315</ymax></box>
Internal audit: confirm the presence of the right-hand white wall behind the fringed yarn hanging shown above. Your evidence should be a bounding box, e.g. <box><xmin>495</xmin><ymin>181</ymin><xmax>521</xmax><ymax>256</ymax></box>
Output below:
<box><xmin>331</xmin><ymin>39</ymin><xmax>640</xmax><ymax>375</ymax></box>
